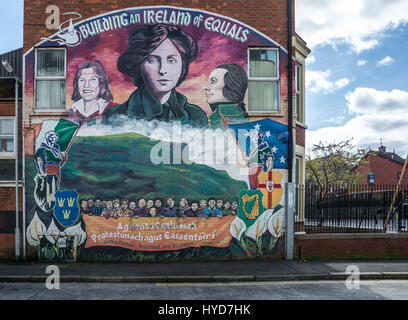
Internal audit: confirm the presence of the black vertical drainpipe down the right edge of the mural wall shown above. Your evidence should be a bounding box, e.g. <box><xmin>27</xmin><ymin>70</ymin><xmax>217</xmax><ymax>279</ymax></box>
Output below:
<box><xmin>287</xmin><ymin>0</ymin><xmax>293</xmax><ymax>183</ymax></box>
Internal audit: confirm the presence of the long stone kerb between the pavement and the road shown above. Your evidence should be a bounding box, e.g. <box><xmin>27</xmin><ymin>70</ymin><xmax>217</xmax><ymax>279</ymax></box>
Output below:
<box><xmin>0</xmin><ymin>272</ymin><xmax>408</xmax><ymax>283</ymax></box>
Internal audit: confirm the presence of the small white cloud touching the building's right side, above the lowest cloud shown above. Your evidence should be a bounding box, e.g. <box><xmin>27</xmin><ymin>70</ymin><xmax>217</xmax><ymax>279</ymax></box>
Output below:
<box><xmin>306</xmin><ymin>69</ymin><xmax>350</xmax><ymax>94</ymax></box>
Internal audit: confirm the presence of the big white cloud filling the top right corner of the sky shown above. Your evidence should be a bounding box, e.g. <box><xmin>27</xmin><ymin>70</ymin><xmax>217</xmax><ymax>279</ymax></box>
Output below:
<box><xmin>296</xmin><ymin>0</ymin><xmax>408</xmax><ymax>53</ymax></box>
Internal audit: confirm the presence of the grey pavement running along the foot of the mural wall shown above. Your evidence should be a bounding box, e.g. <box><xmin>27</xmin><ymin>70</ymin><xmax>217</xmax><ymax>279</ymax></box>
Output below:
<box><xmin>0</xmin><ymin>260</ymin><xmax>408</xmax><ymax>283</ymax></box>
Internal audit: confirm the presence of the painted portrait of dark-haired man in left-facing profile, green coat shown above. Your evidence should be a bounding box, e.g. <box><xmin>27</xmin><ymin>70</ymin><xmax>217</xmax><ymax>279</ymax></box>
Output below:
<box><xmin>202</xmin><ymin>64</ymin><xmax>248</xmax><ymax>127</ymax></box>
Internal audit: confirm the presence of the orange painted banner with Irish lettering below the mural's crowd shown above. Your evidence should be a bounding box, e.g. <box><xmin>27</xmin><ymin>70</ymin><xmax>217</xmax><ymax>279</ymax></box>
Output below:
<box><xmin>84</xmin><ymin>215</ymin><xmax>234</xmax><ymax>251</ymax></box>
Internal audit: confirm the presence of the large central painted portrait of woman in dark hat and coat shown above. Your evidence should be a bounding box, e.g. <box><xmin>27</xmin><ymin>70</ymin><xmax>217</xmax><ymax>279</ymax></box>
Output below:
<box><xmin>103</xmin><ymin>25</ymin><xmax>208</xmax><ymax>126</ymax></box>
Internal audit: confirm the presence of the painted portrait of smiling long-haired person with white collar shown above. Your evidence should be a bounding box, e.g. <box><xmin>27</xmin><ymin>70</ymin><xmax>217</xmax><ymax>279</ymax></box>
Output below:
<box><xmin>69</xmin><ymin>60</ymin><xmax>113</xmax><ymax>119</ymax></box>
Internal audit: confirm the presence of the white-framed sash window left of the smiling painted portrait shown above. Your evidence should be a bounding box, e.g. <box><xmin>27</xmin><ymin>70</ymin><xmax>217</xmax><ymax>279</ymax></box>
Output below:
<box><xmin>35</xmin><ymin>48</ymin><xmax>66</xmax><ymax>110</ymax></box>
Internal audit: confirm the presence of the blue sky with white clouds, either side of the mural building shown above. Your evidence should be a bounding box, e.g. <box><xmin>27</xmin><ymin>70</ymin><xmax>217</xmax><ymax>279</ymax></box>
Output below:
<box><xmin>0</xmin><ymin>0</ymin><xmax>408</xmax><ymax>157</ymax></box>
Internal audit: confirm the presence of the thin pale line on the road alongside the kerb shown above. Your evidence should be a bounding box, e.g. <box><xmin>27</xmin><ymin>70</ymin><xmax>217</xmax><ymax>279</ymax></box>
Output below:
<box><xmin>156</xmin><ymin>279</ymin><xmax>408</xmax><ymax>287</ymax></box>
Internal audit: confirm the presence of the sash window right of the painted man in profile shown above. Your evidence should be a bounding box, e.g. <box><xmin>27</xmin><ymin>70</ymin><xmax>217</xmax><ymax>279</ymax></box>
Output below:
<box><xmin>248</xmin><ymin>48</ymin><xmax>279</xmax><ymax>112</ymax></box>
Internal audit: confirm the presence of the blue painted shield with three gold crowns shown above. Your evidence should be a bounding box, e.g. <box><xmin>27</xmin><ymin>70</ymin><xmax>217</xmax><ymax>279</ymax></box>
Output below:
<box><xmin>54</xmin><ymin>190</ymin><xmax>79</xmax><ymax>227</ymax></box>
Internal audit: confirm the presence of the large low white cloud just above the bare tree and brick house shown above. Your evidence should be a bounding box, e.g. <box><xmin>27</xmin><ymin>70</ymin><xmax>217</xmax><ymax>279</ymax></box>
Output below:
<box><xmin>306</xmin><ymin>88</ymin><xmax>408</xmax><ymax>158</ymax></box>
